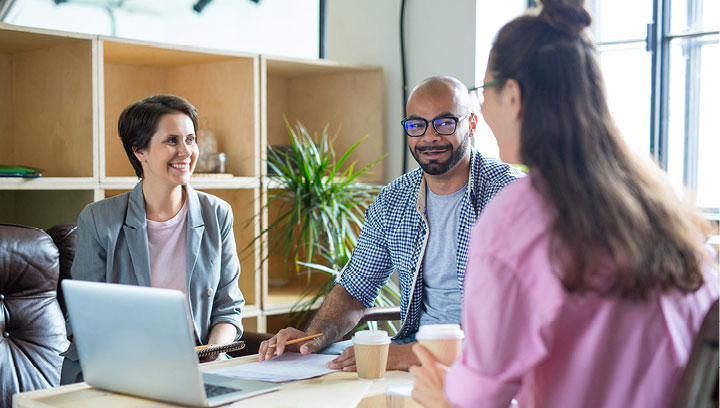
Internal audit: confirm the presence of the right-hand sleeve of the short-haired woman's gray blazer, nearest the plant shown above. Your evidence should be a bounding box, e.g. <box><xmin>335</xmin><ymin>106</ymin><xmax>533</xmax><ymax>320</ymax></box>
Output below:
<box><xmin>210</xmin><ymin>204</ymin><xmax>245</xmax><ymax>339</ymax></box>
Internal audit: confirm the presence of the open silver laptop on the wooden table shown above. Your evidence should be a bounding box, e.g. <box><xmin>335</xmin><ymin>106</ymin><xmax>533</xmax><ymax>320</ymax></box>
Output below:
<box><xmin>62</xmin><ymin>279</ymin><xmax>282</xmax><ymax>407</ymax></box>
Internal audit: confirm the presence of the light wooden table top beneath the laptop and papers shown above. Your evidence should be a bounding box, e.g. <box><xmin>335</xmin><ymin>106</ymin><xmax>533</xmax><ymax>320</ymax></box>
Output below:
<box><xmin>13</xmin><ymin>355</ymin><xmax>417</xmax><ymax>408</ymax></box>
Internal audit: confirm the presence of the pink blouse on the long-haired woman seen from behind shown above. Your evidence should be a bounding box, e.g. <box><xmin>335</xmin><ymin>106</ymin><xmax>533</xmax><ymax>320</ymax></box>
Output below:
<box><xmin>445</xmin><ymin>176</ymin><xmax>718</xmax><ymax>408</ymax></box>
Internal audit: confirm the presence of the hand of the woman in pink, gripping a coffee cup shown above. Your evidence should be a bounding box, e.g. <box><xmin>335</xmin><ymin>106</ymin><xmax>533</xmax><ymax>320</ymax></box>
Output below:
<box><xmin>410</xmin><ymin>344</ymin><xmax>452</xmax><ymax>408</ymax></box>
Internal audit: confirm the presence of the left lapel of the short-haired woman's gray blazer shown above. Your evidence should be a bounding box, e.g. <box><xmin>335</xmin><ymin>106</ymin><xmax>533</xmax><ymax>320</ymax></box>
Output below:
<box><xmin>123</xmin><ymin>181</ymin><xmax>150</xmax><ymax>286</ymax></box>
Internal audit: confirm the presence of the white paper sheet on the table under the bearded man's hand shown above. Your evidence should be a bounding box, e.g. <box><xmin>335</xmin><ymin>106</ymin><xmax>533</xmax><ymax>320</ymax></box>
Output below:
<box><xmin>208</xmin><ymin>353</ymin><xmax>338</xmax><ymax>382</ymax></box>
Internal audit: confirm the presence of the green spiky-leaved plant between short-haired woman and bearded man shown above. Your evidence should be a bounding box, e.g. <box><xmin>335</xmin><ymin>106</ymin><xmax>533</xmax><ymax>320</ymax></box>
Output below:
<box><xmin>256</xmin><ymin>120</ymin><xmax>400</xmax><ymax>331</ymax></box>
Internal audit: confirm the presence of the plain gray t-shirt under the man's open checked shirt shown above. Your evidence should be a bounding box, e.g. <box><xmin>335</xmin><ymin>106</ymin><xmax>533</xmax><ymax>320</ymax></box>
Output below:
<box><xmin>420</xmin><ymin>184</ymin><xmax>467</xmax><ymax>325</ymax></box>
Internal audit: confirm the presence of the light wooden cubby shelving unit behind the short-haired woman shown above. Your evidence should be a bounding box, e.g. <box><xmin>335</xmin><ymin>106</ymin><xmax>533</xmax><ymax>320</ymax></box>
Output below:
<box><xmin>0</xmin><ymin>23</ymin><xmax>384</xmax><ymax>331</ymax></box>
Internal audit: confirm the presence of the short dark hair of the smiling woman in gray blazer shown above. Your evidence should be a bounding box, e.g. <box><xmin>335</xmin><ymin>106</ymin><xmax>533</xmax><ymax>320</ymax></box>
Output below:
<box><xmin>118</xmin><ymin>95</ymin><xmax>198</xmax><ymax>178</ymax></box>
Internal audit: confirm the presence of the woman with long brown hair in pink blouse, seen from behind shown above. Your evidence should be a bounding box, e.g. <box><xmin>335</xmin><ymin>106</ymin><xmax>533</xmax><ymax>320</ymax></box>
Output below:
<box><xmin>411</xmin><ymin>0</ymin><xmax>718</xmax><ymax>407</ymax></box>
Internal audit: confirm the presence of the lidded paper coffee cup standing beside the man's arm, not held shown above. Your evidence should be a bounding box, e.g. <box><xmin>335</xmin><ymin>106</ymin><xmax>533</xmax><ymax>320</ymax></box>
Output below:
<box><xmin>353</xmin><ymin>330</ymin><xmax>390</xmax><ymax>380</ymax></box>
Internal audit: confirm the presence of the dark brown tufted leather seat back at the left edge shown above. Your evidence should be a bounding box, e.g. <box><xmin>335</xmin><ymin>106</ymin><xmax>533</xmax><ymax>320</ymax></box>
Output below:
<box><xmin>0</xmin><ymin>224</ymin><xmax>74</xmax><ymax>407</ymax></box>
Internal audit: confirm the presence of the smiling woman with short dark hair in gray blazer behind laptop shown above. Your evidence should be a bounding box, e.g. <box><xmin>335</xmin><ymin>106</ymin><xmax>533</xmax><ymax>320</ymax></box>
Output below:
<box><xmin>61</xmin><ymin>95</ymin><xmax>245</xmax><ymax>384</ymax></box>
